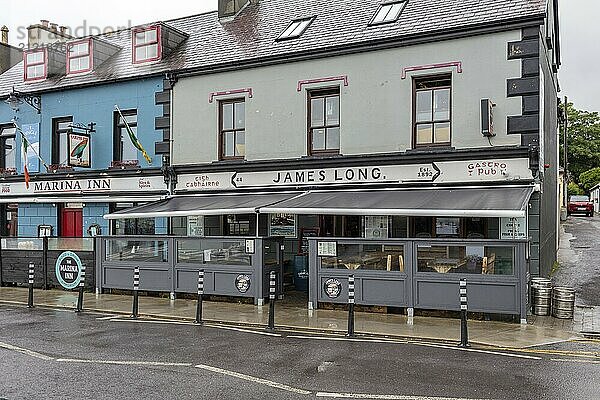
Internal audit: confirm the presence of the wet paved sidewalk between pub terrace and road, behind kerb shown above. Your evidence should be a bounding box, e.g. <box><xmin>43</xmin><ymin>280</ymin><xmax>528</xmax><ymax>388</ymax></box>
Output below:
<box><xmin>0</xmin><ymin>288</ymin><xmax>577</xmax><ymax>348</ymax></box>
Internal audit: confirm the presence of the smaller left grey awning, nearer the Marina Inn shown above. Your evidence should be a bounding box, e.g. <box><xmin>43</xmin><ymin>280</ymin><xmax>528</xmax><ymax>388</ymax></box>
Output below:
<box><xmin>104</xmin><ymin>193</ymin><xmax>299</xmax><ymax>219</ymax></box>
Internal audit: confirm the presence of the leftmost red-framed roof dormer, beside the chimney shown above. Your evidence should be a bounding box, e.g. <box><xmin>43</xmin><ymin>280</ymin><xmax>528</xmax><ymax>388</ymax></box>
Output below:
<box><xmin>23</xmin><ymin>47</ymin><xmax>65</xmax><ymax>82</ymax></box>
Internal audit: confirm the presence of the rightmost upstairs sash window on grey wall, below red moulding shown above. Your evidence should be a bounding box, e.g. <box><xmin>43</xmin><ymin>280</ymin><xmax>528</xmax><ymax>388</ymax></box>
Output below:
<box><xmin>413</xmin><ymin>75</ymin><xmax>452</xmax><ymax>147</ymax></box>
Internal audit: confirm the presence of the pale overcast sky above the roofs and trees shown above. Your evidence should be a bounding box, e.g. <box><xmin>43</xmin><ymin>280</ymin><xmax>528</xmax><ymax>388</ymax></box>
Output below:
<box><xmin>0</xmin><ymin>0</ymin><xmax>600</xmax><ymax>111</ymax></box>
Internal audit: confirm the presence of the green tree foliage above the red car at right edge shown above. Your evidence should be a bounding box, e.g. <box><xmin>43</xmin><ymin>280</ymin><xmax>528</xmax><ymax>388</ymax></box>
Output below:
<box><xmin>560</xmin><ymin>103</ymin><xmax>600</xmax><ymax>182</ymax></box>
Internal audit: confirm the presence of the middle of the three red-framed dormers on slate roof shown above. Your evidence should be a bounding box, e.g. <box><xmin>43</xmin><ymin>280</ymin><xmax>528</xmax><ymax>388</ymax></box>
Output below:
<box><xmin>67</xmin><ymin>37</ymin><xmax>119</xmax><ymax>75</ymax></box>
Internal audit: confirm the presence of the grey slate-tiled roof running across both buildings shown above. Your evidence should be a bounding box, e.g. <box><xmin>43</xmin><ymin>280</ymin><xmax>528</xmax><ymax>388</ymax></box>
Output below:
<box><xmin>0</xmin><ymin>0</ymin><xmax>545</xmax><ymax>96</ymax></box>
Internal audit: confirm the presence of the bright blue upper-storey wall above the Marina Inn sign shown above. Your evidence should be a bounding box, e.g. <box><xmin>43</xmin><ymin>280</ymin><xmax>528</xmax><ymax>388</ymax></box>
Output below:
<box><xmin>0</xmin><ymin>77</ymin><xmax>162</xmax><ymax>172</ymax></box>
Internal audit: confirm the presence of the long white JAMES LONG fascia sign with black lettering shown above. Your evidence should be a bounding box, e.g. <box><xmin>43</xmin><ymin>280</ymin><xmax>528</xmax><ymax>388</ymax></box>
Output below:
<box><xmin>177</xmin><ymin>159</ymin><xmax>532</xmax><ymax>191</ymax></box>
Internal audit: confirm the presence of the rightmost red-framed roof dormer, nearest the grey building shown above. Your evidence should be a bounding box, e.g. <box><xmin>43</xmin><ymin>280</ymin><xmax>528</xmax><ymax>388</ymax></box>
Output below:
<box><xmin>131</xmin><ymin>22</ymin><xmax>188</xmax><ymax>64</ymax></box>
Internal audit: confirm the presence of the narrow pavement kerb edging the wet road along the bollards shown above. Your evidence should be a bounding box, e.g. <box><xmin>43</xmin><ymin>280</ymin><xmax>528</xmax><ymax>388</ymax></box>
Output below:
<box><xmin>0</xmin><ymin>300</ymin><xmax>548</xmax><ymax>349</ymax></box>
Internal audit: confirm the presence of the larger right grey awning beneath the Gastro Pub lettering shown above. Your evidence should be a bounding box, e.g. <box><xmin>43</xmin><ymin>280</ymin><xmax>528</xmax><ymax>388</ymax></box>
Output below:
<box><xmin>260</xmin><ymin>186</ymin><xmax>533</xmax><ymax>217</ymax></box>
